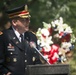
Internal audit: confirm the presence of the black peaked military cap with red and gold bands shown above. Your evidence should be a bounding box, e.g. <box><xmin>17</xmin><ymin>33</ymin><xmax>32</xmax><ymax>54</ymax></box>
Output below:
<box><xmin>7</xmin><ymin>5</ymin><xmax>30</xmax><ymax>18</ymax></box>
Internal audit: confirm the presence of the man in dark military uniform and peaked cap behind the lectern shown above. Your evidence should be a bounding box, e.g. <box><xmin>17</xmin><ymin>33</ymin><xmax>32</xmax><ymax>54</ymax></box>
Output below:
<box><xmin>0</xmin><ymin>5</ymin><xmax>41</xmax><ymax>75</ymax></box>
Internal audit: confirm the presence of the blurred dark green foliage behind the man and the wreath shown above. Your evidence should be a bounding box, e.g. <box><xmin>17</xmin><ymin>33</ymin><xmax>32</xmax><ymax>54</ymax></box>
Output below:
<box><xmin>0</xmin><ymin>0</ymin><xmax>76</xmax><ymax>75</ymax></box>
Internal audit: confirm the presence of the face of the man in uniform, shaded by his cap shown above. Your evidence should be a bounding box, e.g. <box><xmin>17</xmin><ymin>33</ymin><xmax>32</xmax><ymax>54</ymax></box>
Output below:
<box><xmin>16</xmin><ymin>18</ymin><xmax>30</xmax><ymax>33</ymax></box>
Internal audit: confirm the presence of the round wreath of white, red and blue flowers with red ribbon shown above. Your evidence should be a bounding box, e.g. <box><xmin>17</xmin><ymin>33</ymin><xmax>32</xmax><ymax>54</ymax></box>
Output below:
<box><xmin>36</xmin><ymin>17</ymin><xmax>76</xmax><ymax>64</ymax></box>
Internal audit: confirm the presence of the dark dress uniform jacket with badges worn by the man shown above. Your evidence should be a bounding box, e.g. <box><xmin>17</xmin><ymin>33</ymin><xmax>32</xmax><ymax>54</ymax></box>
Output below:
<box><xmin>0</xmin><ymin>28</ymin><xmax>41</xmax><ymax>75</ymax></box>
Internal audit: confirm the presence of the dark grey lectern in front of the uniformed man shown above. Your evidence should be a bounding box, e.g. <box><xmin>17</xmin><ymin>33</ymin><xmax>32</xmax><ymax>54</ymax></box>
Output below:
<box><xmin>27</xmin><ymin>64</ymin><xmax>70</xmax><ymax>75</ymax></box>
